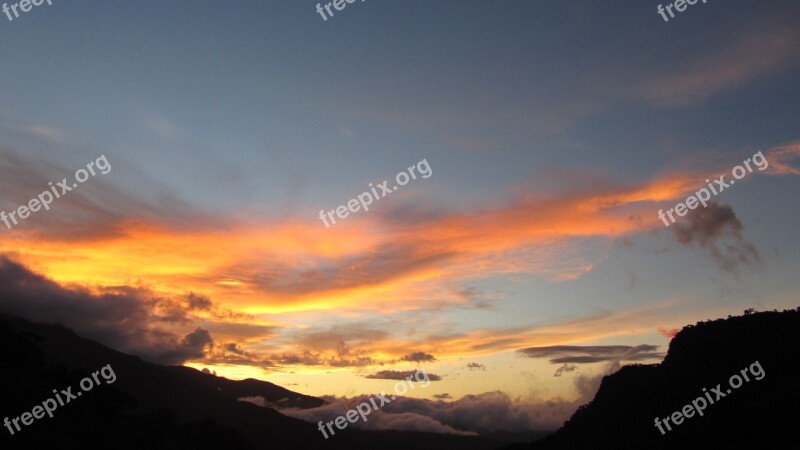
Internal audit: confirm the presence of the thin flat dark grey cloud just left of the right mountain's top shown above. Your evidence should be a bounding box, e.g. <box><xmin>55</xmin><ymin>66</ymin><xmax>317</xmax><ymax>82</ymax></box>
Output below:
<box><xmin>517</xmin><ymin>345</ymin><xmax>664</xmax><ymax>364</ymax></box>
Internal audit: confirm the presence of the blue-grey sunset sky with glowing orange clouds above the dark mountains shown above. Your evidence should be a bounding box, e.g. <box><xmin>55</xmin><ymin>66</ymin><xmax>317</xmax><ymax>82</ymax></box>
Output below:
<box><xmin>0</xmin><ymin>0</ymin><xmax>800</xmax><ymax>431</ymax></box>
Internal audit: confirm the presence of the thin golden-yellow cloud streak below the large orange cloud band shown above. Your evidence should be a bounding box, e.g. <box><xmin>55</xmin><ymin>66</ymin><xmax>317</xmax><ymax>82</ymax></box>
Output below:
<box><xmin>242</xmin><ymin>304</ymin><xmax>676</xmax><ymax>373</ymax></box>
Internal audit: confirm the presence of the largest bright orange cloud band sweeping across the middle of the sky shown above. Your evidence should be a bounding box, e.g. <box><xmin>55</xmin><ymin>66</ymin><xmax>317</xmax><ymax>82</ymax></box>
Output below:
<box><xmin>0</xmin><ymin>144</ymin><xmax>798</xmax><ymax>313</ymax></box>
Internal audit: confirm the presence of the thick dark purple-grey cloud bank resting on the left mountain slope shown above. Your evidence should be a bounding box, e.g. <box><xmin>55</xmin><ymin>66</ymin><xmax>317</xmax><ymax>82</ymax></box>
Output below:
<box><xmin>0</xmin><ymin>256</ymin><xmax>213</xmax><ymax>364</ymax></box>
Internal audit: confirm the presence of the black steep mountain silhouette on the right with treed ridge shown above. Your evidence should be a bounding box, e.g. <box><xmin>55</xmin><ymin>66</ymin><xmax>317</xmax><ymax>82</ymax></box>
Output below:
<box><xmin>506</xmin><ymin>308</ymin><xmax>800</xmax><ymax>450</ymax></box>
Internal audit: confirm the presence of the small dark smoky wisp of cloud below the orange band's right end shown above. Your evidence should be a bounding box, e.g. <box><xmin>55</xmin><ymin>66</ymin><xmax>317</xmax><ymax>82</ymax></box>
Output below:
<box><xmin>670</xmin><ymin>202</ymin><xmax>761</xmax><ymax>272</ymax></box>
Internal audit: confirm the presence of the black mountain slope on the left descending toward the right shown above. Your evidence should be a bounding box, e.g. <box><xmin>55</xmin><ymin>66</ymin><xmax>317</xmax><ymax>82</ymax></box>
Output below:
<box><xmin>0</xmin><ymin>315</ymin><xmax>501</xmax><ymax>450</ymax></box>
